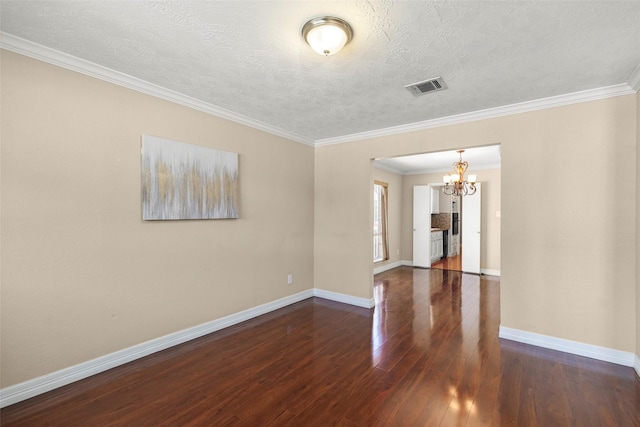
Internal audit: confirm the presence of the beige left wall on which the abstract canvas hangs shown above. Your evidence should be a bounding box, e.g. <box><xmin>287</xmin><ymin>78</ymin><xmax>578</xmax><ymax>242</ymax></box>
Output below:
<box><xmin>1</xmin><ymin>51</ymin><xmax>316</xmax><ymax>387</ymax></box>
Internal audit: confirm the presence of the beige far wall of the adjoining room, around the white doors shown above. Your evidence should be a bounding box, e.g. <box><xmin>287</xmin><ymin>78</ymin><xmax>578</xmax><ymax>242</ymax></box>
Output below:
<box><xmin>402</xmin><ymin>167</ymin><xmax>500</xmax><ymax>271</ymax></box>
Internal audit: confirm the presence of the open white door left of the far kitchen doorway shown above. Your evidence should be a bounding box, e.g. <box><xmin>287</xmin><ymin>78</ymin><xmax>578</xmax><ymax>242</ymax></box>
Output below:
<box><xmin>413</xmin><ymin>185</ymin><xmax>431</xmax><ymax>268</ymax></box>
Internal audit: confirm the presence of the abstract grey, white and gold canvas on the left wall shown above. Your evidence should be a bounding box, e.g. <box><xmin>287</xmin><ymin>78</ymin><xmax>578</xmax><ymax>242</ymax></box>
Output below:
<box><xmin>142</xmin><ymin>135</ymin><xmax>238</xmax><ymax>220</ymax></box>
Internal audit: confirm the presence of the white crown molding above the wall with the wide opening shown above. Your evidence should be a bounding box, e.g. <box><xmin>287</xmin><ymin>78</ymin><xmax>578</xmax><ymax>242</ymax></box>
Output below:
<box><xmin>315</xmin><ymin>83</ymin><xmax>640</xmax><ymax>147</ymax></box>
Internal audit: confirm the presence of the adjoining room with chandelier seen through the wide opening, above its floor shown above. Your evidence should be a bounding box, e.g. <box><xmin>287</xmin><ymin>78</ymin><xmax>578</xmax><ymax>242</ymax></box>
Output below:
<box><xmin>373</xmin><ymin>145</ymin><xmax>501</xmax><ymax>276</ymax></box>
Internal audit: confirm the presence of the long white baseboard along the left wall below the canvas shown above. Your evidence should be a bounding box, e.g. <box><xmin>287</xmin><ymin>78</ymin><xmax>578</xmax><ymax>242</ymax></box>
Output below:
<box><xmin>0</xmin><ymin>289</ymin><xmax>316</xmax><ymax>408</ymax></box>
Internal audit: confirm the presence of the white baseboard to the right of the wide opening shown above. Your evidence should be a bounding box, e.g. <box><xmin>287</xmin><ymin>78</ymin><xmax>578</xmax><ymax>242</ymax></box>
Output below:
<box><xmin>498</xmin><ymin>326</ymin><xmax>640</xmax><ymax>368</ymax></box>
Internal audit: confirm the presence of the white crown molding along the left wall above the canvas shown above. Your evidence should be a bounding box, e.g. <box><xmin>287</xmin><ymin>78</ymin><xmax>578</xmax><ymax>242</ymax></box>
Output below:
<box><xmin>0</xmin><ymin>32</ymin><xmax>315</xmax><ymax>147</ymax></box>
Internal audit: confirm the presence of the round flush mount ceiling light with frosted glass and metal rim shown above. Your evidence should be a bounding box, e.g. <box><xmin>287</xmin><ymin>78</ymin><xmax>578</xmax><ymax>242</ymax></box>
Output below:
<box><xmin>302</xmin><ymin>16</ymin><xmax>353</xmax><ymax>56</ymax></box>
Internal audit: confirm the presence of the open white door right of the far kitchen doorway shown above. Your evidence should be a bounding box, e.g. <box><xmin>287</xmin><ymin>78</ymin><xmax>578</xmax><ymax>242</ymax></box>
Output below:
<box><xmin>462</xmin><ymin>183</ymin><xmax>482</xmax><ymax>274</ymax></box>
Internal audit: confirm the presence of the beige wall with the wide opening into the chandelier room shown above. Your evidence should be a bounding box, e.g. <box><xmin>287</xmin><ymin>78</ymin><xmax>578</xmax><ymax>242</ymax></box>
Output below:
<box><xmin>314</xmin><ymin>95</ymin><xmax>637</xmax><ymax>351</ymax></box>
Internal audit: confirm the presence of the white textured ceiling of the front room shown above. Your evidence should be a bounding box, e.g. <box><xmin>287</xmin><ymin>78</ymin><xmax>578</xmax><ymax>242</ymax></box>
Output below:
<box><xmin>0</xmin><ymin>0</ymin><xmax>640</xmax><ymax>141</ymax></box>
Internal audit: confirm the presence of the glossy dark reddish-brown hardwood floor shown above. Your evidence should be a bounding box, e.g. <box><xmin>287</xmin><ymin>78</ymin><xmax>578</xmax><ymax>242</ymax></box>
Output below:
<box><xmin>0</xmin><ymin>267</ymin><xmax>640</xmax><ymax>427</ymax></box>
